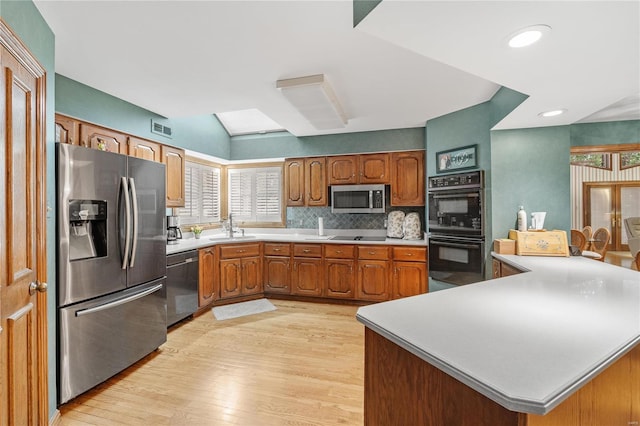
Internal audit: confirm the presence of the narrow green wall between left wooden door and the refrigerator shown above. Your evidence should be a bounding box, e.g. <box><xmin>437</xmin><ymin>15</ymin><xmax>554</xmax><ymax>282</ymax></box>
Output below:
<box><xmin>0</xmin><ymin>0</ymin><xmax>57</xmax><ymax>418</ymax></box>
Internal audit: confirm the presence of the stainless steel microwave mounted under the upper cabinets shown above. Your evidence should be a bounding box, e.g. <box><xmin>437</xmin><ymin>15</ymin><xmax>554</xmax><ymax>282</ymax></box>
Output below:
<box><xmin>331</xmin><ymin>185</ymin><xmax>385</xmax><ymax>213</ymax></box>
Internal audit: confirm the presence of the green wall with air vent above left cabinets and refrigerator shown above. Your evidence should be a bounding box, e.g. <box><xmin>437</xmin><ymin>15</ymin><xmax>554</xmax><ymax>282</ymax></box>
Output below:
<box><xmin>56</xmin><ymin>74</ymin><xmax>230</xmax><ymax>159</ymax></box>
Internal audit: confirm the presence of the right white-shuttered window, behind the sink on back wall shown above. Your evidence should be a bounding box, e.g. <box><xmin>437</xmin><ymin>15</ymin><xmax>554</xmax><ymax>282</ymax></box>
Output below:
<box><xmin>228</xmin><ymin>166</ymin><xmax>284</xmax><ymax>225</ymax></box>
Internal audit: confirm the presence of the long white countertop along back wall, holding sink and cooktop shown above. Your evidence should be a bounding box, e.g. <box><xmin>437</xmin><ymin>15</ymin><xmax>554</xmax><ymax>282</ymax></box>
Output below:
<box><xmin>167</xmin><ymin>228</ymin><xmax>427</xmax><ymax>254</ymax></box>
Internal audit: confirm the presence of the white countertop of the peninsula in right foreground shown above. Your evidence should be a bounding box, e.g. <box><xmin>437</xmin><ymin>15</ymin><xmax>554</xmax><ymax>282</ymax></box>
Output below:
<box><xmin>357</xmin><ymin>254</ymin><xmax>640</xmax><ymax>414</ymax></box>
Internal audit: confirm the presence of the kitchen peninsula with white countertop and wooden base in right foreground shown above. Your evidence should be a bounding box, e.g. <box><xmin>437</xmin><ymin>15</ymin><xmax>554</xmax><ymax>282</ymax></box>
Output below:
<box><xmin>357</xmin><ymin>254</ymin><xmax>640</xmax><ymax>426</ymax></box>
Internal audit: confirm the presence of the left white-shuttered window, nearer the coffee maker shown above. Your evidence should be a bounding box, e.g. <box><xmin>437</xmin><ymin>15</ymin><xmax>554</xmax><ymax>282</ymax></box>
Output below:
<box><xmin>178</xmin><ymin>160</ymin><xmax>221</xmax><ymax>225</ymax></box>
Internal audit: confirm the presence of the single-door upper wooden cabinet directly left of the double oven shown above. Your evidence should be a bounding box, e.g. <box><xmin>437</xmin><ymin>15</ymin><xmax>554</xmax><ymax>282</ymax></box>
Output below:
<box><xmin>391</xmin><ymin>151</ymin><xmax>425</xmax><ymax>206</ymax></box>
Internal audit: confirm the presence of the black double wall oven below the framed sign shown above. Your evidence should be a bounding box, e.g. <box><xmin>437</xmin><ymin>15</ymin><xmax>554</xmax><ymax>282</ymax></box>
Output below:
<box><xmin>429</xmin><ymin>170</ymin><xmax>485</xmax><ymax>285</ymax></box>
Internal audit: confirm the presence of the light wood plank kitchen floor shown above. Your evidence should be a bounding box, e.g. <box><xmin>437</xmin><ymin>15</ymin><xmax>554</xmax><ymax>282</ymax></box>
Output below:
<box><xmin>57</xmin><ymin>300</ymin><xmax>364</xmax><ymax>426</ymax></box>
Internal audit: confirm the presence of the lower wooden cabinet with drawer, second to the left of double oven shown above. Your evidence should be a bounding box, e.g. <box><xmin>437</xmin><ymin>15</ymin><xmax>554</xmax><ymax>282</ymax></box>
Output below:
<box><xmin>356</xmin><ymin>246</ymin><xmax>391</xmax><ymax>301</ymax></box>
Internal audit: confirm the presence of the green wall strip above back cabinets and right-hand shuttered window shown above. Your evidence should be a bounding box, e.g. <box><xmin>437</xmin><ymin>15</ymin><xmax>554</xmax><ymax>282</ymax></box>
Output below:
<box><xmin>230</xmin><ymin>127</ymin><xmax>424</xmax><ymax>160</ymax></box>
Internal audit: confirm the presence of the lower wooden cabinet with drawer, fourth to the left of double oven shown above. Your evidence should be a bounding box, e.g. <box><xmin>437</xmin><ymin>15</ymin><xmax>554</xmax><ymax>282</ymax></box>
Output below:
<box><xmin>291</xmin><ymin>244</ymin><xmax>324</xmax><ymax>296</ymax></box>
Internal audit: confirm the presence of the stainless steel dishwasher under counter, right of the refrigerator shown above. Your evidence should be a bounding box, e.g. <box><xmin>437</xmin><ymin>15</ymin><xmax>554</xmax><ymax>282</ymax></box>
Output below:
<box><xmin>167</xmin><ymin>250</ymin><xmax>198</xmax><ymax>327</ymax></box>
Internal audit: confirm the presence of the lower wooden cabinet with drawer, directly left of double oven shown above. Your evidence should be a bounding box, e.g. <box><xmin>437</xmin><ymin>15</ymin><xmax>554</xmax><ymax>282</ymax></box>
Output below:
<box><xmin>391</xmin><ymin>247</ymin><xmax>427</xmax><ymax>299</ymax></box>
